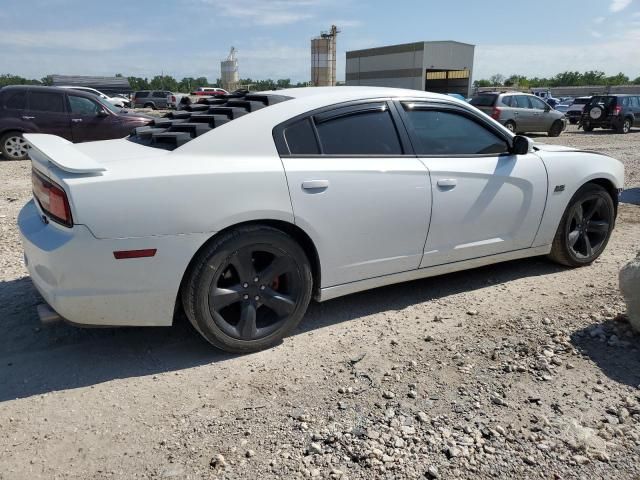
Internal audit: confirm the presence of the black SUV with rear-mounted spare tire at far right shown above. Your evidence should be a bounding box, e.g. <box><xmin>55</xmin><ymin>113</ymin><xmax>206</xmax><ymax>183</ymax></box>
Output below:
<box><xmin>580</xmin><ymin>95</ymin><xmax>640</xmax><ymax>133</ymax></box>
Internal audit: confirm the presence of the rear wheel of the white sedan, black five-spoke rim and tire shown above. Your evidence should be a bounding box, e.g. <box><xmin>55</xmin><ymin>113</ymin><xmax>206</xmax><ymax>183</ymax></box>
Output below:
<box><xmin>181</xmin><ymin>226</ymin><xmax>313</xmax><ymax>353</ymax></box>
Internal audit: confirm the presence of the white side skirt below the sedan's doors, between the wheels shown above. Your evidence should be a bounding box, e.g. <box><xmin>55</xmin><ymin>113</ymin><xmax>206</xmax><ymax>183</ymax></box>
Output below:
<box><xmin>316</xmin><ymin>245</ymin><xmax>551</xmax><ymax>302</ymax></box>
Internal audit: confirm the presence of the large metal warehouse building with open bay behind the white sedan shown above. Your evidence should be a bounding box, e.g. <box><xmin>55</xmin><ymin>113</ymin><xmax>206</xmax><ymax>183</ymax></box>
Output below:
<box><xmin>346</xmin><ymin>41</ymin><xmax>475</xmax><ymax>97</ymax></box>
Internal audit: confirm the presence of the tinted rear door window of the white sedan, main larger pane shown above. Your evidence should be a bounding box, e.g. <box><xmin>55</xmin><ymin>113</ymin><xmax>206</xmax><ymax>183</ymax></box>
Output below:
<box><xmin>316</xmin><ymin>105</ymin><xmax>403</xmax><ymax>155</ymax></box>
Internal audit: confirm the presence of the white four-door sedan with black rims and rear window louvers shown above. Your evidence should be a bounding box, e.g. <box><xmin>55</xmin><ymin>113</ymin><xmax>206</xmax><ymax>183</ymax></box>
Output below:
<box><xmin>18</xmin><ymin>87</ymin><xmax>624</xmax><ymax>352</ymax></box>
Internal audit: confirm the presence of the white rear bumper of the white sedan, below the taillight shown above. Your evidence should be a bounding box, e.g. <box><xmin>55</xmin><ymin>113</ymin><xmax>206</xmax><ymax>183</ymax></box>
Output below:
<box><xmin>18</xmin><ymin>201</ymin><xmax>211</xmax><ymax>326</ymax></box>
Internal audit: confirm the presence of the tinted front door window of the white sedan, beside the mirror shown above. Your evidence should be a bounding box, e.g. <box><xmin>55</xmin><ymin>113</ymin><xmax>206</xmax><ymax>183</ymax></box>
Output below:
<box><xmin>405</xmin><ymin>108</ymin><xmax>508</xmax><ymax>155</ymax></box>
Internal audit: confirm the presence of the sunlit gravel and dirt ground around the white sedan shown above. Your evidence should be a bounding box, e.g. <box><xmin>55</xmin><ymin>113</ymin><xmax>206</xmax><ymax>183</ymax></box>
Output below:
<box><xmin>0</xmin><ymin>128</ymin><xmax>640</xmax><ymax>480</ymax></box>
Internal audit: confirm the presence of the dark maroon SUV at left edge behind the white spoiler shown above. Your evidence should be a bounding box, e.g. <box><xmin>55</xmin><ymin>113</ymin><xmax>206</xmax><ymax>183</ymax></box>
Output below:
<box><xmin>0</xmin><ymin>85</ymin><xmax>152</xmax><ymax>160</ymax></box>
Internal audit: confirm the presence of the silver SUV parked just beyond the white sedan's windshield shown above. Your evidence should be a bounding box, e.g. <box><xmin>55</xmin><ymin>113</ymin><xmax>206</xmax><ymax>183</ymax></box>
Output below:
<box><xmin>469</xmin><ymin>92</ymin><xmax>567</xmax><ymax>137</ymax></box>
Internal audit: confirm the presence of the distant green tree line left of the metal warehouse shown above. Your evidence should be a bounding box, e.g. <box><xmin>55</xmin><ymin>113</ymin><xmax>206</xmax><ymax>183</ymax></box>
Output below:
<box><xmin>0</xmin><ymin>73</ymin><xmax>308</xmax><ymax>93</ymax></box>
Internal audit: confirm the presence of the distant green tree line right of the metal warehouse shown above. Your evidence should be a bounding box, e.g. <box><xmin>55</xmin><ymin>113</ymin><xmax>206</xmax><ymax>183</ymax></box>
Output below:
<box><xmin>473</xmin><ymin>70</ymin><xmax>640</xmax><ymax>88</ymax></box>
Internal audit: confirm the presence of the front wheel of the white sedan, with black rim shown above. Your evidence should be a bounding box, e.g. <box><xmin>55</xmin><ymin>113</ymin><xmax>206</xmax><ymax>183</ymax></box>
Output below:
<box><xmin>549</xmin><ymin>183</ymin><xmax>615</xmax><ymax>267</ymax></box>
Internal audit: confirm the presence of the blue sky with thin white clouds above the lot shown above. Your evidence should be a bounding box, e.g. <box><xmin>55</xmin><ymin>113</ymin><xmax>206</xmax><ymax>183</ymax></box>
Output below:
<box><xmin>0</xmin><ymin>0</ymin><xmax>640</xmax><ymax>82</ymax></box>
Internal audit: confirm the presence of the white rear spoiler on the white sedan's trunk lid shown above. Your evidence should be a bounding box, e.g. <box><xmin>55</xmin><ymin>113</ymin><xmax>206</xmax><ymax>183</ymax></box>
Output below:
<box><xmin>24</xmin><ymin>133</ymin><xmax>106</xmax><ymax>173</ymax></box>
